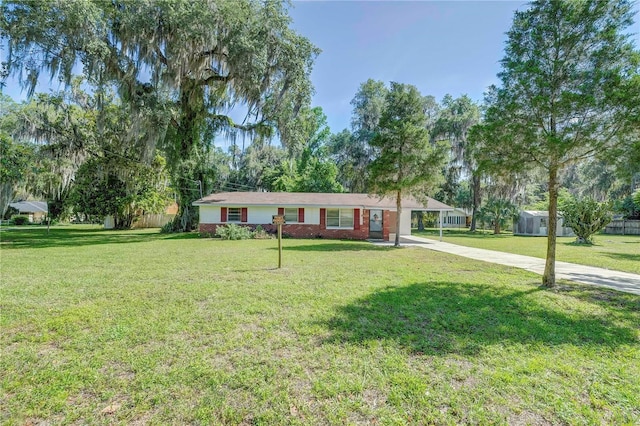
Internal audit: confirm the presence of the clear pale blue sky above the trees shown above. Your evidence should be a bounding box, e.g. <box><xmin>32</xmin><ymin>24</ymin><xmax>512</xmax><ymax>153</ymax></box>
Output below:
<box><xmin>4</xmin><ymin>0</ymin><xmax>640</xmax><ymax>133</ymax></box>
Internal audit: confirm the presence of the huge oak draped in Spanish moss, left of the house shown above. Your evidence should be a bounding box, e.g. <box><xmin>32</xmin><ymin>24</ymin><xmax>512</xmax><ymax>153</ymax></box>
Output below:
<box><xmin>0</xmin><ymin>0</ymin><xmax>319</xmax><ymax>230</ymax></box>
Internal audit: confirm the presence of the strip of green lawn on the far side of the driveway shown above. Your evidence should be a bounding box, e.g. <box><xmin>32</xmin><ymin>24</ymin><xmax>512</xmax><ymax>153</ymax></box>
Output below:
<box><xmin>412</xmin><ymin>229</ymin><xmax>640</xmax><ymax>274</ymax></box>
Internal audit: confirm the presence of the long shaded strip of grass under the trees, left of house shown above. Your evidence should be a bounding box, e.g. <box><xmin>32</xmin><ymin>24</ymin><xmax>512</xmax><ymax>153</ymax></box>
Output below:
<box><xmin>0</xmin><ymin>226</ymin><xmax>198</xmax><ymax>250</ymax></box>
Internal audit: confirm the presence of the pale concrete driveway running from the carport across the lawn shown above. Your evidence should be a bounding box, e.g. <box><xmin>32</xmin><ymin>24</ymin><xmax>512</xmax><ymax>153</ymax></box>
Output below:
<box><xmin>402</xmin><ymin>235</ymin><xmax>640</xmax><ymax>295</ymax></box>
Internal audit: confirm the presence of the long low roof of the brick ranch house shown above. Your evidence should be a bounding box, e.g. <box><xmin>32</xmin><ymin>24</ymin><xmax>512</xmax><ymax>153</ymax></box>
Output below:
<box><xmin>193</xmin><ymin>192</ymin><xmax>453</xmax><ymax>210</ymax></box>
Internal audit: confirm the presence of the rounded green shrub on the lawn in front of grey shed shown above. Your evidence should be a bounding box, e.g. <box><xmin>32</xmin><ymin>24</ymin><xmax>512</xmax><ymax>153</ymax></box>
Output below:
<box><xmin>560</xmin><ymin>197</ymin><xmax>611</xmax><ymax>244</ymax></box>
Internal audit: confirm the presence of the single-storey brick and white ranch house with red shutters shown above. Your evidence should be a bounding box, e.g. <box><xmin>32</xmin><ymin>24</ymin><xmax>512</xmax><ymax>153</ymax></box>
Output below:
<box><xmin>193</xmin><ymin>192</ymin><xmax>453</xmax><ymax>241</ymax></box>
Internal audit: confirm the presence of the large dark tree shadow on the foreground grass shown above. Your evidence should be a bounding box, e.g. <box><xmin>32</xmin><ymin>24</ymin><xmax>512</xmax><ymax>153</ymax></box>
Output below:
<box><xmin>325</xmin><ymin>282</ymin><xmax>638</xmax><ymax>355</ymax></box>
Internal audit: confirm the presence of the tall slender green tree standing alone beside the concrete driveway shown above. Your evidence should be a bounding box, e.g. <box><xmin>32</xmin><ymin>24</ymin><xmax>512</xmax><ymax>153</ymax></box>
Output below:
<box><xmin>480</xmin><ymin>0</ymin><xmax>640</xmax><ymax>287</ymax></box>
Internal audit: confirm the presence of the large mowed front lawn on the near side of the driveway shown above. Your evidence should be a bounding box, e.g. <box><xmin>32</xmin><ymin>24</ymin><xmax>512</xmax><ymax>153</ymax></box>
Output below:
<box><xmin>0</xmin><ymin>227</ymin><xmax>640</xmax><ymax>425</ymax></box>
